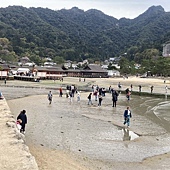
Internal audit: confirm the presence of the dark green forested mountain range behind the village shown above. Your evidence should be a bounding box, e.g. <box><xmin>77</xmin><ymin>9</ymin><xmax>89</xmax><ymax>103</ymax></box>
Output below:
<box><xmin>0</xmin><ymin>6</ymin><xmax>170</xmax><ymax>61</ymax></box>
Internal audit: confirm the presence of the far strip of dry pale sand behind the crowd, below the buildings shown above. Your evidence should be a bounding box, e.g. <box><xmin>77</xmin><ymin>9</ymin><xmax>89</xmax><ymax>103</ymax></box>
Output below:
<box><xmin>0</xmin><ymin>76</ymin><xmax>170</xmax><ymax>99</ymax></box>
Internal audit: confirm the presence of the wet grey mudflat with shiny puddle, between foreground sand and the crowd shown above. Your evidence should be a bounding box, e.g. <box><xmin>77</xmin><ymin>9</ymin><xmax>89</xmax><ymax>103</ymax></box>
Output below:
<box><xmin>3</xmin><ymin>86</ymin><xmax>170</xmax><ymax>162</ymax></box>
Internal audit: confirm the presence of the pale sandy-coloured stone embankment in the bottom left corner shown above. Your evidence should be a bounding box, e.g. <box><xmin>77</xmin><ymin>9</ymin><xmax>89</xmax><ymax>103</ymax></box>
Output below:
<box><xmin>0</xmin><ymin>99</ymin><xmax>38</xmax><ymax>170</ymax></box>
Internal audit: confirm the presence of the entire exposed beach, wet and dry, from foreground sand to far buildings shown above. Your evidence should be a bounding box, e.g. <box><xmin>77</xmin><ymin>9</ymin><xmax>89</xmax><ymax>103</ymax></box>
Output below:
<box><xmin>1</xmin><ymin>77</ymin><xmax>170</xmax><ymax>170</ymax></box>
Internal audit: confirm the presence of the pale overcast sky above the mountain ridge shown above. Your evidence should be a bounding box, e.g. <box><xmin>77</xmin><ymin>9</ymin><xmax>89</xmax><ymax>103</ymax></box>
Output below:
<box><xmin>0</xmin><ymin>0</ymin><xmax>170</xmax><ymax>19</ymax></box>
